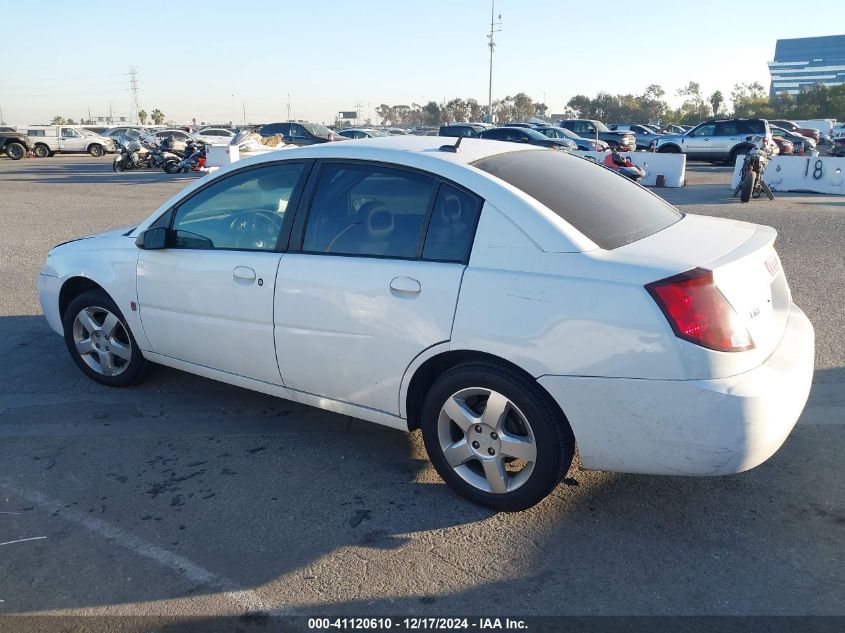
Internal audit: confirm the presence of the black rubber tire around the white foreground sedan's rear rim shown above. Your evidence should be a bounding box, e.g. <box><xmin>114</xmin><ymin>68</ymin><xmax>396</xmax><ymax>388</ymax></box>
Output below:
<box><xmin>420</xmin><ymin>361</ymin><xmax>575</xmax><ymax>512</ymax></box>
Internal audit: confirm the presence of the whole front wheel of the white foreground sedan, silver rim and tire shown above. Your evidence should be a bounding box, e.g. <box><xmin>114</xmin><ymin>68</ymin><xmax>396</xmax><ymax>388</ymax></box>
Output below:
<box><xmin>63</xmin><ymin>290</ymin><xmax>145</xmax><ymax>387</ymax></box>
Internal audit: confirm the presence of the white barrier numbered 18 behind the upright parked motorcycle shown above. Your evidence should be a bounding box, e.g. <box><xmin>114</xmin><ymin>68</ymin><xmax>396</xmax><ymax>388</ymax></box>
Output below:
<box><xmin>731</xmin><ymin>156</ymin><xmax>845</xmax><ymax>195</ymax></box>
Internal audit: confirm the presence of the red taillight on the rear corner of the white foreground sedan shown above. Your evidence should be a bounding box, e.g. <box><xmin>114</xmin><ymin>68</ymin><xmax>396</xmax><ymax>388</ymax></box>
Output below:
<box><xmin>646</xmin><ymin>268</ymin><xmax>754</xmax><ymax>352</ymax></box>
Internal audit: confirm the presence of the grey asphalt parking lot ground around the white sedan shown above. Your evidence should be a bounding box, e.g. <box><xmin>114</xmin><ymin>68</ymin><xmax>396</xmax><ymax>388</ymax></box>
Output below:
<box><xmin>0</xmin><ymin>156</ymin><xmax>845</xmax><ymax>616</ymax></box>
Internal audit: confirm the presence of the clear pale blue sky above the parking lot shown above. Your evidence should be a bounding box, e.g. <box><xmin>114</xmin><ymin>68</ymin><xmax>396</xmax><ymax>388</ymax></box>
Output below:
<box><xmin>0</xmin><ymin>0</ymin><xmax>845</xmax><ymax>124</ymax></box>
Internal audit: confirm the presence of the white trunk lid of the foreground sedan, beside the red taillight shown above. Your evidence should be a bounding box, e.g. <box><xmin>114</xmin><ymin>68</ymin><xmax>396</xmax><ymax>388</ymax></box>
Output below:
<box><xmin>617</xmin><ymin>215</ymin><xmax>791</xmax><ymax>375</ymax></box>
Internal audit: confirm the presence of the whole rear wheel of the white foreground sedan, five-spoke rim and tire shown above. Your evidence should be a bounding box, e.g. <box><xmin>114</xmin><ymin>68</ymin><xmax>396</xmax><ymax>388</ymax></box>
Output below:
<box><xmin>421</xmin><ymin>362</ymin><xmax>575</xmax><ymax>511</ymax></box>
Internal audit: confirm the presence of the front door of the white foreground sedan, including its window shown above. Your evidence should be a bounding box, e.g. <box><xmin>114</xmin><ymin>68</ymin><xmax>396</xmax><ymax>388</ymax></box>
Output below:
<box><xmin>137</xmin><ymin>161</ymin><xmax>310</xmax><ymax>384</ymax></box>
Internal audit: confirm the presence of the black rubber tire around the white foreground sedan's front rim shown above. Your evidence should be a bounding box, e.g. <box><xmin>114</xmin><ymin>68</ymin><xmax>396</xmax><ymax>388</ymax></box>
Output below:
<box><xmin>62</xmin><ymin>290</ymin><xmax>146</xmax><ymax>387</ymax></box>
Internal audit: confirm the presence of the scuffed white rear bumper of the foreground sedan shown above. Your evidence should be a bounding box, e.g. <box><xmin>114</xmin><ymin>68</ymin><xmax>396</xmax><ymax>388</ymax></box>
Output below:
<box><xmin>539</xmin><ymin>304</ymin><xmax>815</xmax><ymax>475</ymax></box>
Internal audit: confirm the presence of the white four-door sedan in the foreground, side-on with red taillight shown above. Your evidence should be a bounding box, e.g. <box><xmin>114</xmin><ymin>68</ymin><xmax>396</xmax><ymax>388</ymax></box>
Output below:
<box><xmin>38</xmin><ymin>136</ymin><xmax>814</xmax><ymax>510</ymax></box>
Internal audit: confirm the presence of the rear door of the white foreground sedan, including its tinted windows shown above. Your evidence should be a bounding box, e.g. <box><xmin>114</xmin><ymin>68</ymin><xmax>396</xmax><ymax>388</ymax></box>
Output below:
<box><xmin>275</xmin><ymin>162</ymin><xmax>480</xmax><ymax>415</ymax></box>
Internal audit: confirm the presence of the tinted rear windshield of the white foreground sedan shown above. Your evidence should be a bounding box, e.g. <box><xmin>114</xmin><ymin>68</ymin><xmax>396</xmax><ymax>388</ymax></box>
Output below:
<box><xmin>472</xmin><ymin>150</ymin><xmax>683</xmax><ymax>249</ymax></box>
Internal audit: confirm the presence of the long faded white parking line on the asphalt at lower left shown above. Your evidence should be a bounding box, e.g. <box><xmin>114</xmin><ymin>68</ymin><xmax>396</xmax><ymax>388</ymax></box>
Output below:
<box><xmin>0</xmin><ymin>482</ymin><xmax>285</xmax><ymax>615</ymax></box>
